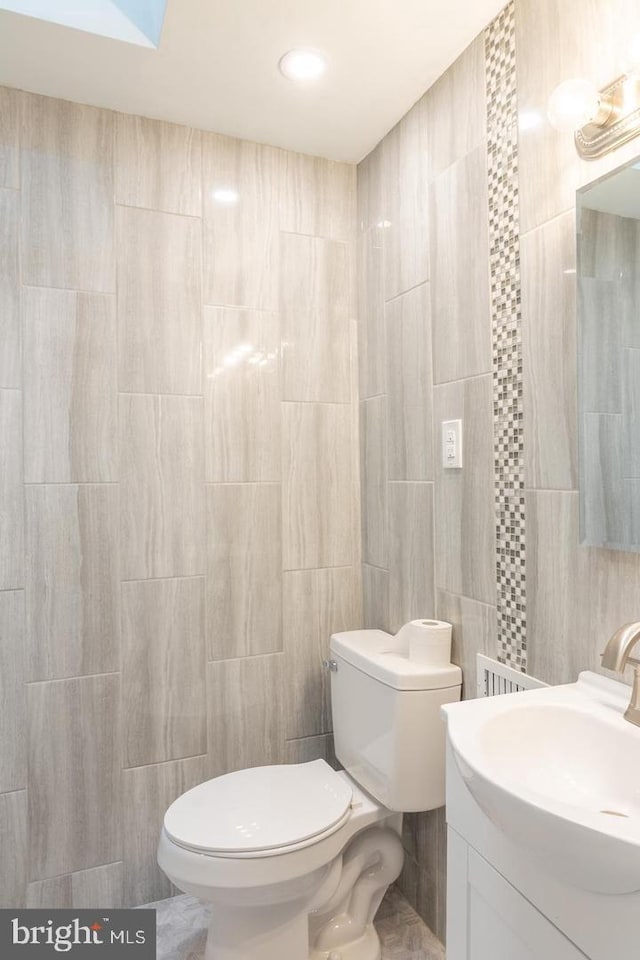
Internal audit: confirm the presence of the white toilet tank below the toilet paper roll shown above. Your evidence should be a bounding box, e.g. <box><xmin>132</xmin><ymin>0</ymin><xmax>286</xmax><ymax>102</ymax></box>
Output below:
<box><xmin>330</xmin><ymin>630</ymin><xmax>462</xmax><ymax>813</ymax></box>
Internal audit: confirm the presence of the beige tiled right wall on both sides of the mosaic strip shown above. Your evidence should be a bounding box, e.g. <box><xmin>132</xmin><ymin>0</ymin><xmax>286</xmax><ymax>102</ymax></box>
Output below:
<box><xmin>358</xmin><ymin>0</ymin><xmax>640</xmax><ymax>937</ymax></box>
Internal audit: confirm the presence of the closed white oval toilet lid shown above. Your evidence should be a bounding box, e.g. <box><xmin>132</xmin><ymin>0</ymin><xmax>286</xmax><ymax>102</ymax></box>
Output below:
<box><xmin>164</xmin><ymin>760</ymin><xmax>352</xmax><ymax>857</ymax></box>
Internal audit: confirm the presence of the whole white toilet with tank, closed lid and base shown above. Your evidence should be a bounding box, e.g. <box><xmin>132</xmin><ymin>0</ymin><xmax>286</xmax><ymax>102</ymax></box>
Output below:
<box><xmin>158</xmin><ymin>630</ymin><xmax>462</xmax><ymax>960</ymax></box>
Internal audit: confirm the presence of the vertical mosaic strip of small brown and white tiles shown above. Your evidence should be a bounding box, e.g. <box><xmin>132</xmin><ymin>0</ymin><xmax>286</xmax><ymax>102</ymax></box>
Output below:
<box><xmin>485</xmin><ymin>2</ymin><xmax>527</xmax><ymax>672</ymax></box>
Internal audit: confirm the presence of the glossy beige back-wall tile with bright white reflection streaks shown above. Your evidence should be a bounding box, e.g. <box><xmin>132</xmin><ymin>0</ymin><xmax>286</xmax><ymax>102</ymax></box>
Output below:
<box><xmin>204</xmin><ymin>307</ymin><xmax>280</xmax><ymax>483</ymax></box>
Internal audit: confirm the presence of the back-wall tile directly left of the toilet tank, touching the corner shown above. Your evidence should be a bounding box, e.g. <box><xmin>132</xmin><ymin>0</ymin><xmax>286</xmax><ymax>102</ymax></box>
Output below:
<box><xmin>283</xmin><ymin>567</ymin><xmax>360</xmax><ymax>738</ymax></box>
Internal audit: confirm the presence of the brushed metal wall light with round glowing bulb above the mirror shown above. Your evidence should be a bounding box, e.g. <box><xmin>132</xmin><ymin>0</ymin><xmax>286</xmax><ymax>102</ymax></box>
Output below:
<box><xmin>548</xmin><ymin>34</ymin><xmax>640</xmax><ymax>160</ymax></box>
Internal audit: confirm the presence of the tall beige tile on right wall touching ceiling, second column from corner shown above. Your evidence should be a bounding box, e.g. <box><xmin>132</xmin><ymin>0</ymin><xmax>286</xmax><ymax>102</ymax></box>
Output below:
<box><xmin>382</xmin><ymin>97</ymin><xmax>429</xmax><ymax>300</ymax></box>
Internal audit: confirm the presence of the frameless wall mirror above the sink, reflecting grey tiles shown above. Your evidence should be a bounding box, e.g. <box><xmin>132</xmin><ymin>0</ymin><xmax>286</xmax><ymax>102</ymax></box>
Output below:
<box><xmin>577</xmin><ymin>161</ymin><xmax>640</xmax><ymax>551</ymax></box>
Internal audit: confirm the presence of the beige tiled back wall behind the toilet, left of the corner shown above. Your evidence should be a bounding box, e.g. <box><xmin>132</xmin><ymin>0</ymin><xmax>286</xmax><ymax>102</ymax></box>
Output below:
<box><xmin>0</xmin><ymin>88</ymin><xmax>362</xmax><ymax>907</ymax></box>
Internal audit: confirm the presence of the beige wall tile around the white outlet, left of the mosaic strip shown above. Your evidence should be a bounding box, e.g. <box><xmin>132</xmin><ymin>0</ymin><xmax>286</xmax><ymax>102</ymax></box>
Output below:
<box><xmin>434</xmin><ymin>375</ymin><xmax>496</xmax><ymax>604</ymax></box>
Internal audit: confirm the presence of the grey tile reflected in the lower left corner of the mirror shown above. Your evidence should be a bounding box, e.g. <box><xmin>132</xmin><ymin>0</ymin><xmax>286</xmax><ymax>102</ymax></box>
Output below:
<box><xmin>581</xmin><ymin>413</ymin><xmax>629</xmax><ymax>547</ymax></box>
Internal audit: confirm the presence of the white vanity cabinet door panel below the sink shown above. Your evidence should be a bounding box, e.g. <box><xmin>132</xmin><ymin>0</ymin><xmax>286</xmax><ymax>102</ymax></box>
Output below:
<box><xmin>447</xmin><ymin>828</ymin><xmax>585</xmax><ymax>960</ymax></box>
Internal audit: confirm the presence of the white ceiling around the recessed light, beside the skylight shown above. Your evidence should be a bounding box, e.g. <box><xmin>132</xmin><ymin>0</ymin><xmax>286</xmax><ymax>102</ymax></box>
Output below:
<box><xmin>0</xmin><ymin>0</ymin><xmax>504</xmax><ymax>162</ymax></box>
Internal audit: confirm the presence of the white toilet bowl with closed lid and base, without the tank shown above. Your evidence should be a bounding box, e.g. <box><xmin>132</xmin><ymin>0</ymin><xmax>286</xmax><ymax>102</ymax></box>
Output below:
<box><xmin>158</xmin><ymin>760</ymin><xmax>403</xmax><ymax>960</ymax></box>
